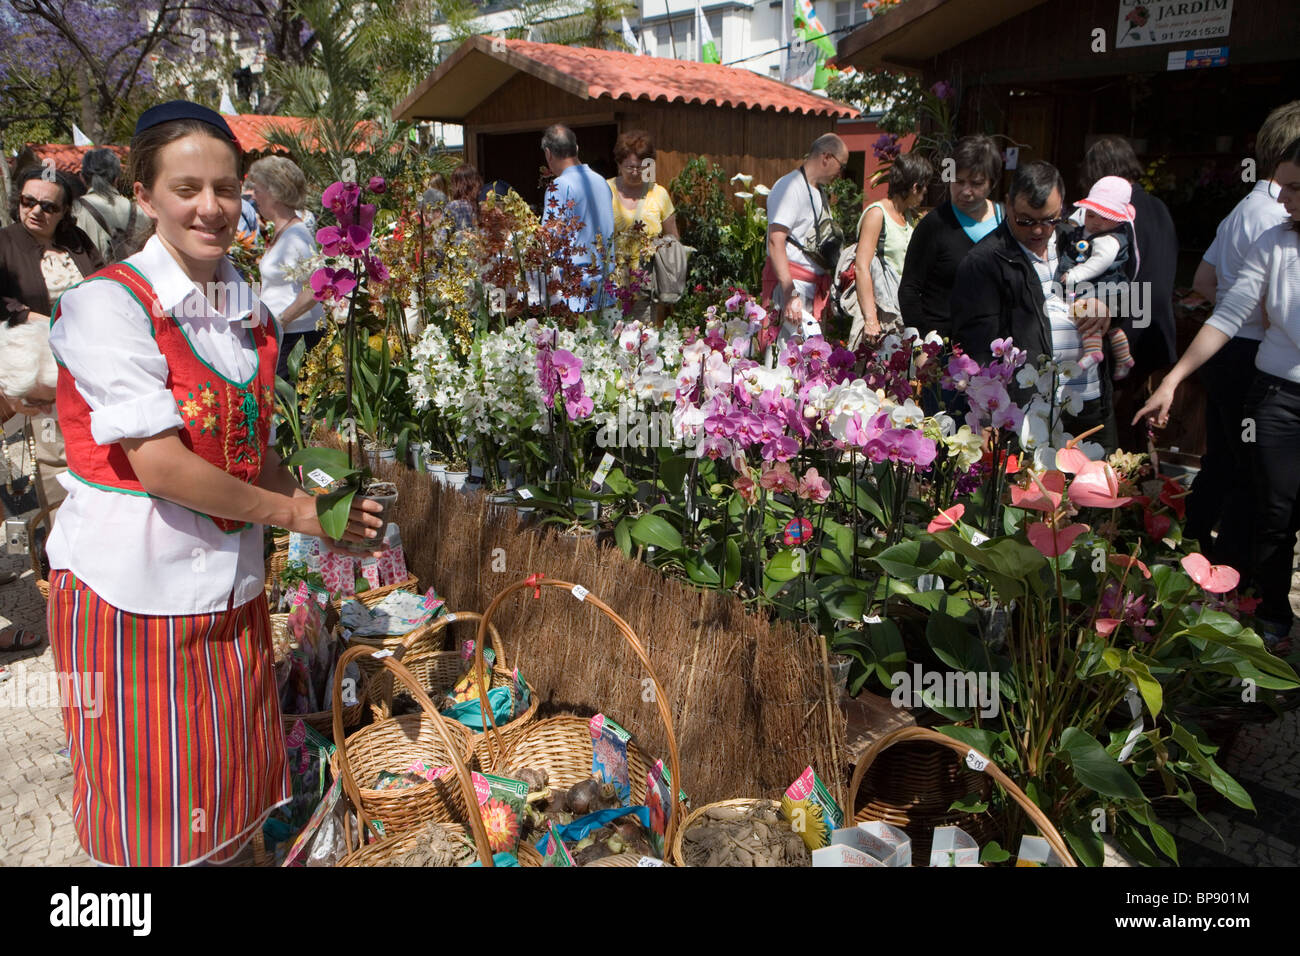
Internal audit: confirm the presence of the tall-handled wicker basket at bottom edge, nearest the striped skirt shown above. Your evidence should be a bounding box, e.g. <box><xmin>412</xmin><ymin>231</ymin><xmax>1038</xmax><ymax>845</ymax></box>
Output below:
<box><xmin>335</xmin><ymin>648</ymin><xmax>542</xmax><ymax>866</ymax></box>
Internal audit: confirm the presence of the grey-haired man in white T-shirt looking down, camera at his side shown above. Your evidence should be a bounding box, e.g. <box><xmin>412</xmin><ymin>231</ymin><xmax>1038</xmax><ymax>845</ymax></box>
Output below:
<box><xmin>763</xmin><ymin>133</ymin><xmax>849</xmax><ymax>338</ymax></box>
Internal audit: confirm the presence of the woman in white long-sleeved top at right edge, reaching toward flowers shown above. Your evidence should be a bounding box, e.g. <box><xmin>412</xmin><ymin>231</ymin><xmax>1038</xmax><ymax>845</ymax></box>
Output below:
<box><xmin>1134</xmin><ymin>139</ymin><xmax>1300</xmax><ymax>645</ymax></box>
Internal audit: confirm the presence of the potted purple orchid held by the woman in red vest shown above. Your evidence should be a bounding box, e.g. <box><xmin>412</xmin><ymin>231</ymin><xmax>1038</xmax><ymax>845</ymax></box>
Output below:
<box><xmin>276</xmin><ymin>177</ymin><xmax>398</xmax><ymax>551</ymax></box>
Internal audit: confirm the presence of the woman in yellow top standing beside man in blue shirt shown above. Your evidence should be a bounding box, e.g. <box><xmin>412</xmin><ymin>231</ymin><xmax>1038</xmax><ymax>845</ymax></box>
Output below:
<box><xmin>608</xmin><ymin>130</ymin><xmax>681</xmax><ymax>321</ymax></box>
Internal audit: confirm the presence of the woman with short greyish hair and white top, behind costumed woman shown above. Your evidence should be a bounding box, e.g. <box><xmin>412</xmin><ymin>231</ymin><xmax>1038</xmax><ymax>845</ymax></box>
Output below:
<box><xmin>247</xmin><ymin>156</ymin><xmax>325</xmax><ymax>378</ymax></box>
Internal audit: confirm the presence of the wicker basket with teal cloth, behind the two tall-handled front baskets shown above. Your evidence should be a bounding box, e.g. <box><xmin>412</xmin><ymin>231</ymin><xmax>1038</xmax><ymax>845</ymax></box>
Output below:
<box><xmin>368</xmin><ymin>611</ymin><xmax>538</xmax><ymax>766</ymax></box>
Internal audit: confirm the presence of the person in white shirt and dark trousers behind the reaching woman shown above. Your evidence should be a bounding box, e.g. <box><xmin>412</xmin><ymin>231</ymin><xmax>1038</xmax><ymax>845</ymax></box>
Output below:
<box><xmin>1184</xmin><ymin>100</ymin><xmax>1300</xmax><ymax>568</ymax></box>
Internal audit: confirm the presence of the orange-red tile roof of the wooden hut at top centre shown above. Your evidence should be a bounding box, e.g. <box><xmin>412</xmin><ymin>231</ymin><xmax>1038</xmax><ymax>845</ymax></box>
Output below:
<box><xmin>506</xmin><ymin>40</ymin><xmax>859</xmax><ymax>116</ymax></box>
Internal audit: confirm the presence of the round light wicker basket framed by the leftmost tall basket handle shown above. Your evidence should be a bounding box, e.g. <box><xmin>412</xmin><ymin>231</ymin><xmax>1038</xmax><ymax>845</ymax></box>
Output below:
<box><xmin>330</xmin><ymin>646</ymin><xmax>475</xmax><ymax>836</ymax></box>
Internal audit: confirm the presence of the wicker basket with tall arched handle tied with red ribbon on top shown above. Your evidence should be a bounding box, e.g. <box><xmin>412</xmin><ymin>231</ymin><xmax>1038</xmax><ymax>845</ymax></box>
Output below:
<box><xmin>475</xmin><ymin>575</ymin><xmax>683</xmax><ymax>866</ymax></box>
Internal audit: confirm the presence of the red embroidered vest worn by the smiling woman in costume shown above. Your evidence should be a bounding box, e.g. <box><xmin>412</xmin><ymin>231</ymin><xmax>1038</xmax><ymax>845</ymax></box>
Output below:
<box><xmin>49</xmin><ymin>263</ymin><xmax>280</xmax><ymax>533</ymax></box>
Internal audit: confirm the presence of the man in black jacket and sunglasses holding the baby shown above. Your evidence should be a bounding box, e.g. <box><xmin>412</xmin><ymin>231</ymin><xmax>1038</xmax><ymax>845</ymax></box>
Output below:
<box><xmin>952</xmin><ymin>160</ymin><xmax>1115</xmax><ymax>451</ymax></box>
